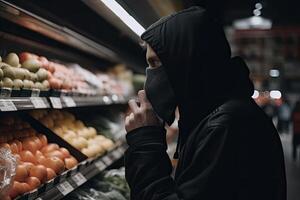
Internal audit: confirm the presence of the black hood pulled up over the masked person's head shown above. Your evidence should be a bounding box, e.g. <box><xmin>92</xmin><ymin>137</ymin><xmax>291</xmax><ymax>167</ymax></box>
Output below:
<box><xmin>141</xmin><ymin>7</ymin><xmax>253</xmax><ymax>153</ymax></box>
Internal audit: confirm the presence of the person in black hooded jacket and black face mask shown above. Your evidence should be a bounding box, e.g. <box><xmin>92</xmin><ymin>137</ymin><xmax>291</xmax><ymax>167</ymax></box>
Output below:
<box><xmin>125</xmin><ymin>7</ymin><xmax>286</xmax><ymax>200</ymax></box>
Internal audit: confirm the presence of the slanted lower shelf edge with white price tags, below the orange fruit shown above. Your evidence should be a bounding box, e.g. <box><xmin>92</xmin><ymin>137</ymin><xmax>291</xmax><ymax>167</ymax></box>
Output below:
<box><xmin>16</xmin><ymin>143</ymin><xmax>126</xmax><ymax>200</ymax></box>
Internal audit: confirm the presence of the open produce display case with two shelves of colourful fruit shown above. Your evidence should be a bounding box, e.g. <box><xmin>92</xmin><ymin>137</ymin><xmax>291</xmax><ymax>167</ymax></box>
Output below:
<box><xmin>0</xmin><ymin>0</ymin><xmax>139</xmax><ymax>200</ymax></box>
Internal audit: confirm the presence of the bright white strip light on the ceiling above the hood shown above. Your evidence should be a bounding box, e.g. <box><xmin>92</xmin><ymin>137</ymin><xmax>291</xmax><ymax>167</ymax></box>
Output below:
<box><xmin>101</xmin><ymin>0</ymin><xmax>145</xmax><ymax>36</ymax></box>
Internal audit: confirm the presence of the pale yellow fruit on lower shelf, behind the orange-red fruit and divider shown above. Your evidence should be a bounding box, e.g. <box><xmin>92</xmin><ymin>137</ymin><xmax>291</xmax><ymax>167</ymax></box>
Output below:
<box><xmin>31</xmin><ymin>110</ymin><xmax>115</xmax><ymax>157</ymax></box>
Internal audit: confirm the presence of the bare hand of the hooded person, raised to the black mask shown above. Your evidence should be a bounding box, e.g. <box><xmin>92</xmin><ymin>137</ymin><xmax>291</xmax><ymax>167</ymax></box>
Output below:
<box><xmin>125</xmin><ymin>90</ymin><xmax>162</xmax><ymax>133</ymax></box>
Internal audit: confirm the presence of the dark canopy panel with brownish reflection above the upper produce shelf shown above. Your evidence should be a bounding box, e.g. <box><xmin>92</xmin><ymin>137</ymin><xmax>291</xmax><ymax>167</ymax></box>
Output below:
<box><xmin>0</xmin><ymin>0</ymin><xmax>120</xmax><ymax>62</ymax></box>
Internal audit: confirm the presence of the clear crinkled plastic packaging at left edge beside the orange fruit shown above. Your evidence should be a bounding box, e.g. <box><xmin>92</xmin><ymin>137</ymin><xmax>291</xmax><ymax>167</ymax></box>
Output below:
<box><xmin>0</xmin><ymin>147</ymin><xmax>17</xmax><ymax>199</ymax></box>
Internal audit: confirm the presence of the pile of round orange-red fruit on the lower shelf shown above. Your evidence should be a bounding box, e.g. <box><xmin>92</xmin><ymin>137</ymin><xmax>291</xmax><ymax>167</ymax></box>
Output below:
<box><xmin>0</xmin><ymin>115</ymin><xmax>78</xmax><ymax>199</ymax></box>
